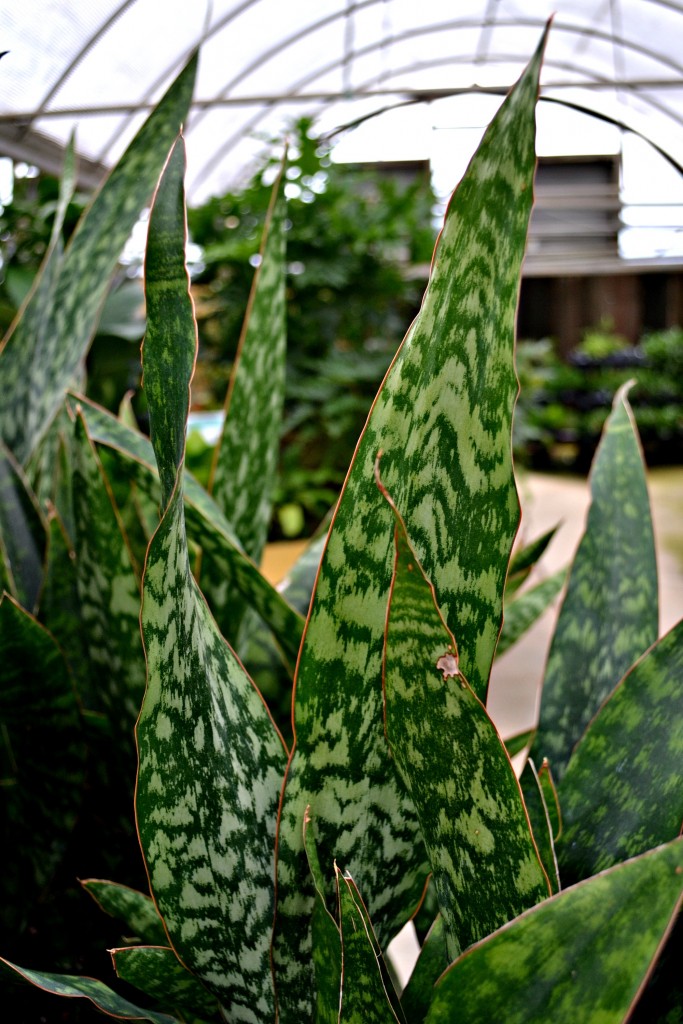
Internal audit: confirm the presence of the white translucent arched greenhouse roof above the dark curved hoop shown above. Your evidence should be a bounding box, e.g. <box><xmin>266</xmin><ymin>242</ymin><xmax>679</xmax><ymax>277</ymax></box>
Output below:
<box><xmin>0</xmin><ymin>0</ymin><xmax>683</xmax><ymax>201</ymax></box>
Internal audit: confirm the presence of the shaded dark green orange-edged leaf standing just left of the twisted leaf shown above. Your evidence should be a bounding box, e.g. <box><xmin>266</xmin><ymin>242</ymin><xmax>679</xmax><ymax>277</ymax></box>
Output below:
<box><xmin>73</xmin><ymin>407</ymin><xmax>145</xmax><ymax>736</ymax></box>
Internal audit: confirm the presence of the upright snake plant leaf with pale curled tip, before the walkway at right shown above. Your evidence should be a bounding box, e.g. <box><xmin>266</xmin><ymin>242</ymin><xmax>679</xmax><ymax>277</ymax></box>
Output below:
<box><xmin>531</xmin><ymin>386</ymin><xmax>658</xmax><ymax>781</ymax></box>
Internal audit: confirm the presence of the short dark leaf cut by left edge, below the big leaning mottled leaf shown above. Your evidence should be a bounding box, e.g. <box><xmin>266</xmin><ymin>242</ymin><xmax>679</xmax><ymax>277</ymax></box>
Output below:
<box><xmin>0</xmin><ymin>443</ymin><xmax>47</xmax><ymax>611</ymax></box>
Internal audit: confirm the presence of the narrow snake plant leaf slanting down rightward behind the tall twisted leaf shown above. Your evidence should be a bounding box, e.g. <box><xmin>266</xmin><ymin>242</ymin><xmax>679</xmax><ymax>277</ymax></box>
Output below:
<box><xmin>71</xmin><ymin>395</ymin><xmax>303</xmax><ymax>662</ymax></box>
